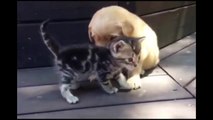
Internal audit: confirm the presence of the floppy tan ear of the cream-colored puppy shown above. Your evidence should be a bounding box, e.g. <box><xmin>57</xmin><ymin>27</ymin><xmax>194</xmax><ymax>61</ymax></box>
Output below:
<box><xmin>121</xmin><ymin>21</ymin><xmax>134</xmax><ymax>36</ymax></box>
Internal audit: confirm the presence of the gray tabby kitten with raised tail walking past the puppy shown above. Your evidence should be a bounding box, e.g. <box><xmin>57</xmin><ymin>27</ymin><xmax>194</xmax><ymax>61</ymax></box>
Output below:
<box><xmin>40</xmin><ymin>20</ymin><xmax>143</xmax><ymax>103</ymax></box>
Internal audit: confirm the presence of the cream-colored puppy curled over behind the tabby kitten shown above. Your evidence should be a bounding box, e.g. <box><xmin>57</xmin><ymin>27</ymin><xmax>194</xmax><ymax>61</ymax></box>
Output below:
<box><xmin>88</xmin><ymin>6</ymin><xmax>159</xmax><ymax>89</ymax></box>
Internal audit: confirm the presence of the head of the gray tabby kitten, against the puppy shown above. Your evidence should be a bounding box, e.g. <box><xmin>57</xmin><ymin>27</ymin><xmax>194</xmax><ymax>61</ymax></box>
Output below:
<box><xmin>110</xmin><ymin>37</ymin><xmax>143</xmax><ymax>70</ymax></box>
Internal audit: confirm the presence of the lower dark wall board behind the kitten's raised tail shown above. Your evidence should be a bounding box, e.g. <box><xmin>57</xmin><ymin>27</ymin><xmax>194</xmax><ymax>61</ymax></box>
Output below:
<box><xmin>17</xmin><ymin>21</ymin><xmax>89</xmax><ymax>68</ymax></box>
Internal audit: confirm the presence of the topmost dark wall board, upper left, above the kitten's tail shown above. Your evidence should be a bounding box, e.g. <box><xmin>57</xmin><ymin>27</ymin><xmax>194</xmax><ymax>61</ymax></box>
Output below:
<box><xmin>17</xmin><ymin>1</ymin><xmax>117</xmax><ymax>23</ymax></box>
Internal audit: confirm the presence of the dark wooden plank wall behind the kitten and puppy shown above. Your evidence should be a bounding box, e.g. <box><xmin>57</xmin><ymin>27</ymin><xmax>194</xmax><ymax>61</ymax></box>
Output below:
<box><xmin>17</xmin><ymin>1</ymin><xmax>196</xmax><ymax>69</ymax></box>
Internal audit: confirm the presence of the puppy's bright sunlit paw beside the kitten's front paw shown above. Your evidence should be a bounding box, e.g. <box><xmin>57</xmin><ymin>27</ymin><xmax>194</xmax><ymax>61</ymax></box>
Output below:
<box><xmin>127</xmin><ymin>77</ymin><xmax>141</xmax><ymax>89</ymax></box>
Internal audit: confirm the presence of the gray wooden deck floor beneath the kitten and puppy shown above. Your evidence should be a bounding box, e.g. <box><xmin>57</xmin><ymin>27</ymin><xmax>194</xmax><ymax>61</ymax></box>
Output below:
<box><xmin>17</xmin><ymin>33</ymin><xmax>196</xmax><ymax>118</ymax></box>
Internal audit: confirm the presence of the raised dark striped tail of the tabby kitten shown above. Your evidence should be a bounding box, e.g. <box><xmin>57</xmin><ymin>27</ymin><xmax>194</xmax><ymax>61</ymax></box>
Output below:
<box><xmin>40</xmin><ymin>19</ymin><xmax>60</xmax><ymax>57</ymax></box>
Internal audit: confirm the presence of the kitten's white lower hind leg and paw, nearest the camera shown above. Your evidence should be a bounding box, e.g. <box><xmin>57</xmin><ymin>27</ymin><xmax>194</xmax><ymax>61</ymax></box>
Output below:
<box><xmin>60</xmin><ymin>83</ymin><xmax>79</xmax><ymax>104</ymax></box>
